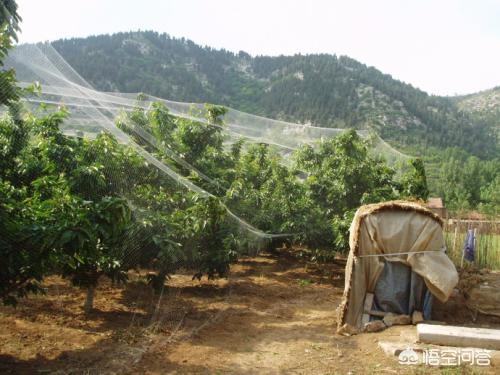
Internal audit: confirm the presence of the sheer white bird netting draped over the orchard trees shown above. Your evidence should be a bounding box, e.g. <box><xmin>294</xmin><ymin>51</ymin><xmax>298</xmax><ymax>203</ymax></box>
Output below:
<box><xmin>1</xmin><ymin>44</ymin><xmax>408</xmax><ymax>253</ymax></box>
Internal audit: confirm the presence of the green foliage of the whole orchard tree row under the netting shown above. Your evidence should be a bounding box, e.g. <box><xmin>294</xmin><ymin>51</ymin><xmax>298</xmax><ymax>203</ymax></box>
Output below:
<box><xmin>0</xmin><ymin>94</ymin><xmax>438</xmax><ymax>302</ymax></box>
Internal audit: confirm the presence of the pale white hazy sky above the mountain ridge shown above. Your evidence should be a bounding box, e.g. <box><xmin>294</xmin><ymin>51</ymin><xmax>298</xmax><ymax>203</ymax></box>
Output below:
<box><xmin>17</xmin><ymin>0</ymin><xmax>500</xmax><ymax>95</ymax></box>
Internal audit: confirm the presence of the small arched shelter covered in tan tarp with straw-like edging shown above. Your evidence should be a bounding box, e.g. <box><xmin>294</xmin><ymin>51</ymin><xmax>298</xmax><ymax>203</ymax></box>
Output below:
<box><xmin>338</xmin><ymin>201</ymin><xmax>458</xmax><ymax>333</ymax></box>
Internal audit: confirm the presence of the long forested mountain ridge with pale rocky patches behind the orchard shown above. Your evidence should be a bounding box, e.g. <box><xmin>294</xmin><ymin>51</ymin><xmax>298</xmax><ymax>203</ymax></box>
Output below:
<box><xmin>47</xmin><ymin>31</ymin><xmax>500</xmax><ymax>158</ymax></box>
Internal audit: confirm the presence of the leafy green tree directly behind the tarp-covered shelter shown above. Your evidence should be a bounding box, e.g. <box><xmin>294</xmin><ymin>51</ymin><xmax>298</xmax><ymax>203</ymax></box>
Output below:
<box><xmin>296</xmin><ymin>130</ymin><xmax>398</xmax><ymax>250</ymax></box>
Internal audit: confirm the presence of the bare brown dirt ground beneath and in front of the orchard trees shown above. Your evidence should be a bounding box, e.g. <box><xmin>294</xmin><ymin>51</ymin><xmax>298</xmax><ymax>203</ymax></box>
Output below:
<box><xmin>0</xmin><ymin>252</ymin><xmax>498</xmax><ymax>374</ymax></box>
